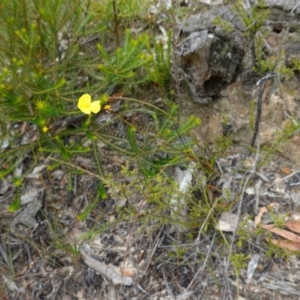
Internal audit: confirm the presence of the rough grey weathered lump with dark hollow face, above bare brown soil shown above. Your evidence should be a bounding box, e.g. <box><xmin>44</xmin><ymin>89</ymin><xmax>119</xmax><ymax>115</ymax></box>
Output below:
<box><xmin>176</xmin><ymin>6</ymin><xmax>245</xmax><ymax>103</ymax></box>
